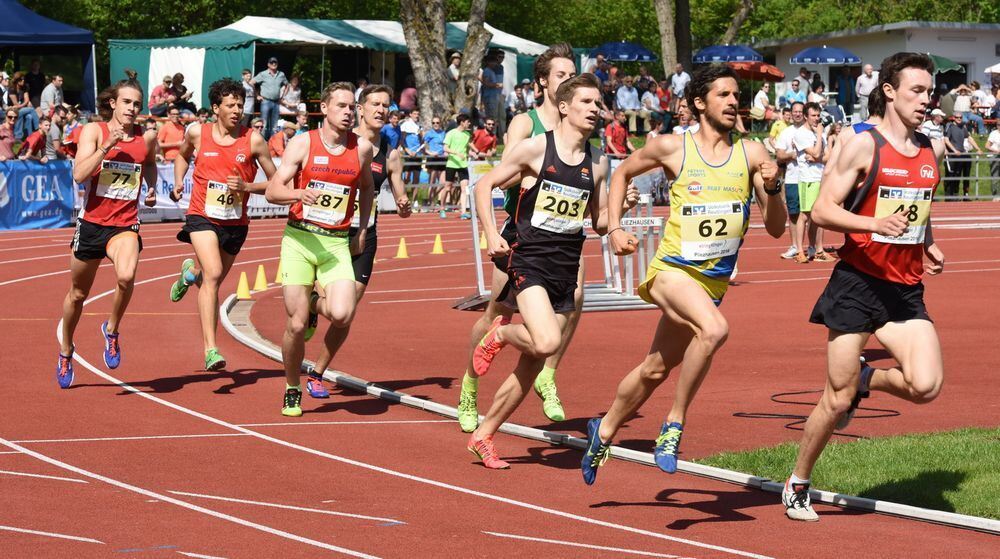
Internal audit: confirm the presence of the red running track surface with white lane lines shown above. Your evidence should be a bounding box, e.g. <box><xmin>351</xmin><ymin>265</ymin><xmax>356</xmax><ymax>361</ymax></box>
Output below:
<box><xmin>0</xmin><ymin>204</ymin><xmax>1000</xmax><ymax>558</ymax></box>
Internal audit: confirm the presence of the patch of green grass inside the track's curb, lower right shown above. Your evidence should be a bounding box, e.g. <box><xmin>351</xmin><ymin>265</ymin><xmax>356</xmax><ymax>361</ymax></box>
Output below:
<box><xmin>696</xmin><ymin>428</ymin><xmax>1000</xmax><ymax>519</ymax></box>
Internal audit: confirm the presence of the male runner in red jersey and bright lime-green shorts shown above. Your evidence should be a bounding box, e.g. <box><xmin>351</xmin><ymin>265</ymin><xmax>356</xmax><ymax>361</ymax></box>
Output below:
<box><xmin>266</xmin><ymin>82</ymin><xmax>374</xmax><ymax>417</ymax></box>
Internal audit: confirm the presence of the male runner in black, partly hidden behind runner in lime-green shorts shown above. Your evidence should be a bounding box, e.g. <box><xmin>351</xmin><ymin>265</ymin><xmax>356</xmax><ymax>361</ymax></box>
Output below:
<box><xmin>306</xmin><ymin>85</ymin><xmax>412</xmax><ymax>398</ymax></box>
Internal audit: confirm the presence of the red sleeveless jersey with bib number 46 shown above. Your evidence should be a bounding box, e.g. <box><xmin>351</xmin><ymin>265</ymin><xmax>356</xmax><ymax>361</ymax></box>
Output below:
<box><xmin>187</xmin><ymin>124</ymin><xmax>257</xmax><ymax>225</ymax></box>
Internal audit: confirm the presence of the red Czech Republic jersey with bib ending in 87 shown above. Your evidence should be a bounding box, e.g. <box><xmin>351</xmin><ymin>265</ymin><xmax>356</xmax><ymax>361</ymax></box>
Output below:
<box><xmin>288</xmin><ymin>129</ymin><xmax>361</xmax><ymax>231</ymax></box>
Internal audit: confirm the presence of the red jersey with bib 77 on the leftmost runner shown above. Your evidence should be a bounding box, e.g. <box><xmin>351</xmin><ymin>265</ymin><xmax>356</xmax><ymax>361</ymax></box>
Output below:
<box><xmin>80</xmin><ymin>122</ymin><xmax>149</xmax><ymax>227</ymax></box>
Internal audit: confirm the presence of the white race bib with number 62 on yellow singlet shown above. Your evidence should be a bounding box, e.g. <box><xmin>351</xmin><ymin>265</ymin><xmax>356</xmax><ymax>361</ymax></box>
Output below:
<box><xmin>680</xmin><ymin>202</ymin><xmax>744</xmax><ymax>261</ymax></box>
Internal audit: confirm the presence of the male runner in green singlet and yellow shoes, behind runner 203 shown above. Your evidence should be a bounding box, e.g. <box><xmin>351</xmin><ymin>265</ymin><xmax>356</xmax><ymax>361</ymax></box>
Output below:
<box><xmin>458</xmin><ymin>43</ymin><xmax>584</xmax><ymax>433</ymax></box>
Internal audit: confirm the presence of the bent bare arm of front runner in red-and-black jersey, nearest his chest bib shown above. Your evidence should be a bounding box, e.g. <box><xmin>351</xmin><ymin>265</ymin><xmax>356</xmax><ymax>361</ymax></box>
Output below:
<box><xmin>812</xmin><ymin>134</ymin><xmax>909</xmax><ymax>237</ymax></box>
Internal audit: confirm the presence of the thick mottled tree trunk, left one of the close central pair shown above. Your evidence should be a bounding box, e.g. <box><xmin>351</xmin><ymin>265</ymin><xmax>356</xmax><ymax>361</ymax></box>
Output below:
<box><xmin>399</xmin><ymin>0</ymin><xmax>451</xmax><ymax>128</ymax></box>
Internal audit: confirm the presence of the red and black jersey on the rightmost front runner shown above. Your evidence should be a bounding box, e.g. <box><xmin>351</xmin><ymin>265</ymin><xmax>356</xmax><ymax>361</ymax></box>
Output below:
<box><xmin>838</xmin><ymin>128</ymin><xmax>941</xmax><ymax>285</ymax></box>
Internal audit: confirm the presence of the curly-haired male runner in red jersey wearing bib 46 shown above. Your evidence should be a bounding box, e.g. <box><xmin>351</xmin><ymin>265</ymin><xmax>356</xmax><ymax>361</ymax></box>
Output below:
<box><xmin>170</xmin><ymin>78</ymin><xmax>274</xmax><ymax>371</ymax></box>
